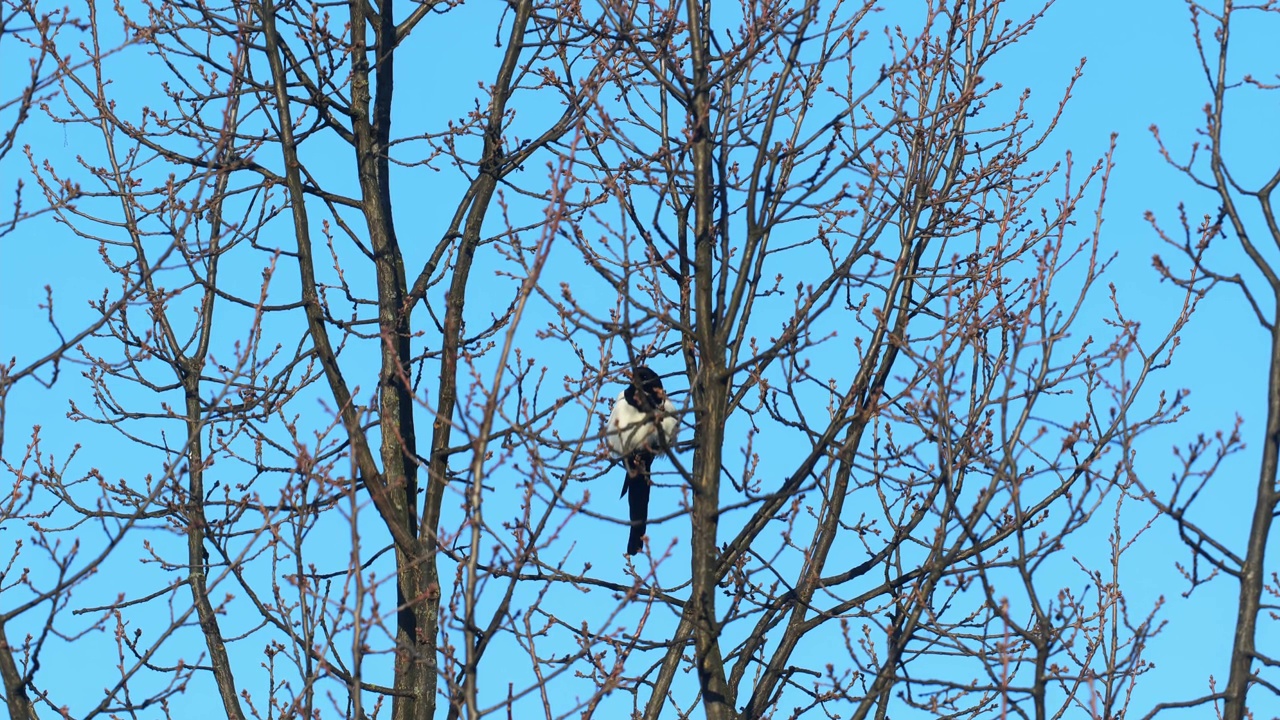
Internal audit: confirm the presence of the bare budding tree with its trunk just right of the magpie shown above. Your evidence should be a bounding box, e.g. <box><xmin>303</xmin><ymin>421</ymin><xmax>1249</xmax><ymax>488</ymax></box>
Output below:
<box><xmin>547</xmin><ymin>3</ymin><xmax>1194</xmax><ymax>717</ymax></box>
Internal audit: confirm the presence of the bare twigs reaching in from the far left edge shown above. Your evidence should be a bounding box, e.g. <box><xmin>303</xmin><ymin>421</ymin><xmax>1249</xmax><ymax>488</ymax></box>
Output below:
<box><xmin>0</xmin><ymin>0</ymin><xmax>154</xmax><ymax>720</ymax></box>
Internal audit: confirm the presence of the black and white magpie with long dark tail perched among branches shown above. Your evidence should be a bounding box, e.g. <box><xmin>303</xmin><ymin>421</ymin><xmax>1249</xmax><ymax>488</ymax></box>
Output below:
<box><xmin>604</xmin><ymin>365</ymin><xmax>678</xmax><ymax>555</ymax></box>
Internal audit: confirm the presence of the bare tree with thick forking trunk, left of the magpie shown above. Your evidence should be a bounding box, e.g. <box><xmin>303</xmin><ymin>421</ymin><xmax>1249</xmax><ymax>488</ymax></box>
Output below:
<box><xmin>15</xmin><ymin>3</ymin><xmax>619</xmax><ymax>717</ymax></box>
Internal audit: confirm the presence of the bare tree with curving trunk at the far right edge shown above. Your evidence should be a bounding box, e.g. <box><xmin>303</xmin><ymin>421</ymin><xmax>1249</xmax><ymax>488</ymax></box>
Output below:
<box><xmin>1146</xmin><ymin>0</ymin><xmax>1280</xmax><ymax>720</ymax></box>
